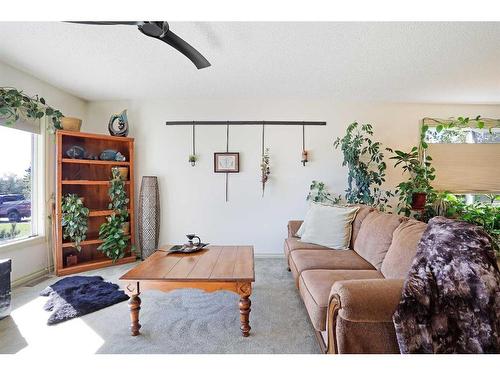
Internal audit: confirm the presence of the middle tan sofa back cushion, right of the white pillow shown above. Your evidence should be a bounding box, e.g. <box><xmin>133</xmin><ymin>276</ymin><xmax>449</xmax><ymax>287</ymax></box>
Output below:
<box><xmin>354</xmin><ymin>211</ymin><xmax>407</xmax><ymax>270</ymax></box>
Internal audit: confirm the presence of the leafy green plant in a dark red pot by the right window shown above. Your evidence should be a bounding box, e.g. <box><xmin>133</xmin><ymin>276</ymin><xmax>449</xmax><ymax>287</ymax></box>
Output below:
<box><xmin>390</xmin><ymin>147</ymin><xmax>436</xmax><ymax>216</ymax></box>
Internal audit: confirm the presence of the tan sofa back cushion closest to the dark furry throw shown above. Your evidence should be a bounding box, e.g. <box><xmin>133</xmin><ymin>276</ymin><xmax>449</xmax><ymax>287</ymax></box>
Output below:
<box><xmin>380</xmin><ymin>219</ymin><xmax>427</xmax><ymax>279</ymax></box>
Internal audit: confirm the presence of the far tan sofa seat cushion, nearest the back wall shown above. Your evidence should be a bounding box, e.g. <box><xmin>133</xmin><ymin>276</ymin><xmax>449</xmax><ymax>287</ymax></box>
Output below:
<box><xmin>289</xmin><ymin>249</ymin><xmax>374</xmax><ymax>285</ymax></box>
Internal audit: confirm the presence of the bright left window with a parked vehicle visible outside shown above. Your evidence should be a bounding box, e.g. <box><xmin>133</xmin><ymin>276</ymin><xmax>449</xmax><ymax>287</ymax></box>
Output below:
<box><xmin>0</xmin><ymin>126</ymin><xmax>40</xmax><ymax>245</ymax></box>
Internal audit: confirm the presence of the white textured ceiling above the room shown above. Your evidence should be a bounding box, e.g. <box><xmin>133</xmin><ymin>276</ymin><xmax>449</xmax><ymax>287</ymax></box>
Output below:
<box><xmin>0</xmin><ymin>22</ymin><xmax>500</xmax><ymax>103</ymax></box>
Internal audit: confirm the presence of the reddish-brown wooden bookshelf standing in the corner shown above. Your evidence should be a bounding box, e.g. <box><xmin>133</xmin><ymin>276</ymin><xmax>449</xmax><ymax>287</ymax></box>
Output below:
<box><xmin>54</xmin><ymin>130</ymin><xmax>136</xmax><ymax>276</ymax></box>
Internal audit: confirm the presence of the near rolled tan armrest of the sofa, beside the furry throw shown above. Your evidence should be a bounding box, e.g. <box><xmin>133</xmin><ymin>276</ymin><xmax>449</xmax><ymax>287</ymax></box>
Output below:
<box><xmin>330</xmin><ymin>279</ymin><xmax>404</xmax><ymax>323</ymax></box>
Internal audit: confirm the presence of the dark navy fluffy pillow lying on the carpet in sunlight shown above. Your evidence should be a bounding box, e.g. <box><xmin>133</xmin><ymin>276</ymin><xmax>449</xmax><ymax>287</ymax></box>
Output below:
<box><xmin>40</xmin><ymin>276</ymin><xmax>128</xmax><ymax>325</ymax></box>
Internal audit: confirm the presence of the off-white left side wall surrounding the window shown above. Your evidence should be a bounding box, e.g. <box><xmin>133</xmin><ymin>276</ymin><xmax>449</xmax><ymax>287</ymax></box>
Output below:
<box><xmin>0</xmin><ymin>62</ymin><xmax>87</xmax><ymax>281</ymax></box>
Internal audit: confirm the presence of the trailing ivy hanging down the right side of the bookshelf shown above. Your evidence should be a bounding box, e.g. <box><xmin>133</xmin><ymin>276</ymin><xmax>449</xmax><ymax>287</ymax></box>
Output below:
<box><xmin>97</xmin><ymin>167</ymin><xmax>130</xmax><ymax>262</ymax></box>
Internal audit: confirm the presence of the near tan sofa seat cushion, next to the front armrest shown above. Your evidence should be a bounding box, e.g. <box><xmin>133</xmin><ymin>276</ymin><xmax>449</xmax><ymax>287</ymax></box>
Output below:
<box><xmin>299</xmin><ymin>270</ymin><xmax>383</xmax><ymax>331</ymax></box>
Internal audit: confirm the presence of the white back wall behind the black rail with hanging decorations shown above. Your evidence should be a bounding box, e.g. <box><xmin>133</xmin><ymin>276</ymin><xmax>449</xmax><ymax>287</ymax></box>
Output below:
<box><xmin>85</xmin><ymin>98</ymin><xmax>500</xmax><ymax>254</ymax></box>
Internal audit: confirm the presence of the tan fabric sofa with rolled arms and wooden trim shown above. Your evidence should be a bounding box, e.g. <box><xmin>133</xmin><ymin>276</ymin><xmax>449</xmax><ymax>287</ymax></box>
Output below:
<box><xmin>284</xmin><ymin>205</ymin><xmax>426</xmax><ymax>353</ymax></box>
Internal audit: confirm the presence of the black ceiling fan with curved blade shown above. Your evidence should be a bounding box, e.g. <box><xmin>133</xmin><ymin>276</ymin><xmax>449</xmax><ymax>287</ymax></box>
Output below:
<box><xmin>69</xmin><ymin>21</ymin><xmax>210</xmax><ymax>69</ymax></box>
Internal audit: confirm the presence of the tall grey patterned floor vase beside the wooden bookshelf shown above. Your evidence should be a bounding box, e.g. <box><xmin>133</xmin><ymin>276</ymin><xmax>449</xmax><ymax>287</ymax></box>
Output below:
<box><xmin>138</xmin><ymin>176</ymin><xmax>160</xmax><ymax>259</ymax></box>
